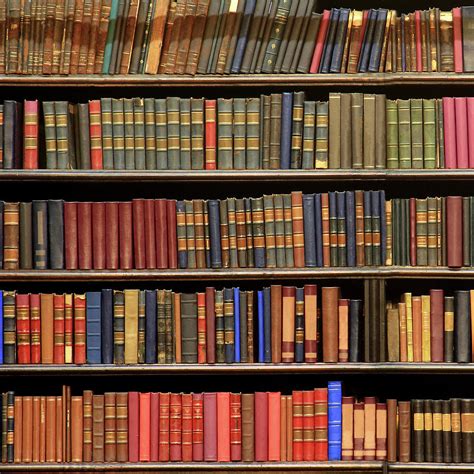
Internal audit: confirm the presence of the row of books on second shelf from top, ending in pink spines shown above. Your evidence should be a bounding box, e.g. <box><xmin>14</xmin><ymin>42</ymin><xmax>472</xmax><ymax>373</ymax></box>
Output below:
<box><xmin>6</xmin><ymin>92</ymin><xmax>474</xmax><ymax>170</ymax></box>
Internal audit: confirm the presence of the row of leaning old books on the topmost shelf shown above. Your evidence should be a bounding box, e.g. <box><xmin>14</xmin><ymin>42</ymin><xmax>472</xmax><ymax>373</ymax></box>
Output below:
<box><xmin>0</xmin><ymin>0</ymin><xmax>474</xmax><ymax>75</ymax></box>
